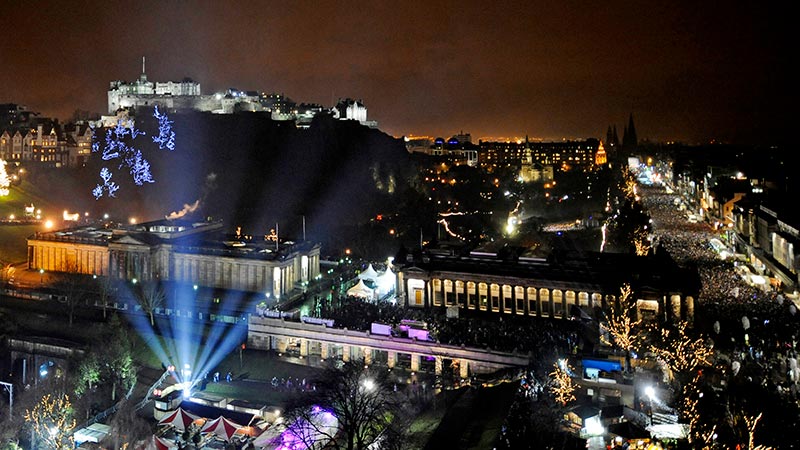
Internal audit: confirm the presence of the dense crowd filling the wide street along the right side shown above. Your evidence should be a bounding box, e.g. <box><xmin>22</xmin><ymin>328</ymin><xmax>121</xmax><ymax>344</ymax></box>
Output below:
<box><xmin>642</xmin><ymin>188</ymin><xmax>800</xmax><ymax>399</ymax></box>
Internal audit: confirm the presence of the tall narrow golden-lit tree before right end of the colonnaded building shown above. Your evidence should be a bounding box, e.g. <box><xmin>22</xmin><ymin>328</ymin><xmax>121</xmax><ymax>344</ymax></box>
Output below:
<box><xmin>600</xmin><ymin>284</ymin><xmax>647</xmax><ymax>369</ymax></box>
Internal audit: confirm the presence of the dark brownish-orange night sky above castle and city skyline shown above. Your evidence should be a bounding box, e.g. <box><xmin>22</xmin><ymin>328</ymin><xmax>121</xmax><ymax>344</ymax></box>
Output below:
<box><xmin>0</xmin><ymin>1</ymin><xmax>797</xmax><ymax>143</ymax></box>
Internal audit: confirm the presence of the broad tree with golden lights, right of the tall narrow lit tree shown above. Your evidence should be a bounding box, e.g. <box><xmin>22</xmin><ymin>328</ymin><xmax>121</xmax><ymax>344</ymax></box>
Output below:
<box><xmin>650</xmin><ymin>322</ymin><xmax>714</xmax><ymax>379</ymax></box>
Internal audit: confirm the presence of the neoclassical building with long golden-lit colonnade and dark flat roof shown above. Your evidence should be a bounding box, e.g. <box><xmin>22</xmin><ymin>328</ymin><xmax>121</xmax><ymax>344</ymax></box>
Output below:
<box><xmin>397</xmin><ymin>253</ymin><xmax>699</xmax><ymax>321</ymax></box>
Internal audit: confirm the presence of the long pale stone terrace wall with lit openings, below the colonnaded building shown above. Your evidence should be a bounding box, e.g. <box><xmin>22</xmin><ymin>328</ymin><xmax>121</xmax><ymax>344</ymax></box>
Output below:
<box><xmin>247</xmin><ymin>315</ymin><xmax>530</xmax><ymax>378</ymax></box>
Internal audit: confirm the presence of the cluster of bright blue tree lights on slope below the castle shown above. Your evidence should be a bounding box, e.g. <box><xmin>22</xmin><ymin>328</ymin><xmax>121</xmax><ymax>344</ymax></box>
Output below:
<box><xmin>92</xmin><ymin>106</ymin><xmax>175</xmax><ymax>199</ymax></box>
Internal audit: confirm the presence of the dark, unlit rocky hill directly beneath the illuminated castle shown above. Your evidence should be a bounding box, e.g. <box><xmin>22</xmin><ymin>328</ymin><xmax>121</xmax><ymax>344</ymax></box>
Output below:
<box><xmin>79</xmin><ymin>113</ymin><xmax>412</xmax><ymax>238</ymax></box>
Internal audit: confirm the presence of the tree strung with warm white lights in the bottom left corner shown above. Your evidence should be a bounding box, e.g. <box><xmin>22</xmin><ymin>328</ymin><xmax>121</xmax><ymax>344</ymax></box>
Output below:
<box><xmin>25</xmin><ymin>394</ymin><xmax>75</xmax><ymax>450</ymax></box>
